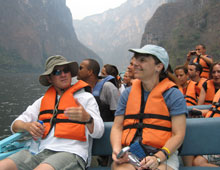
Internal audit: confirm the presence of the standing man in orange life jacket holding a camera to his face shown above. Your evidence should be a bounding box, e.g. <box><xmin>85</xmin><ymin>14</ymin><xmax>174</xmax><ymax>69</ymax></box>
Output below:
<box><xmin>185</xmin><ymin>44</ymin><xmax>213</xmax><ymax>79</ymax></box>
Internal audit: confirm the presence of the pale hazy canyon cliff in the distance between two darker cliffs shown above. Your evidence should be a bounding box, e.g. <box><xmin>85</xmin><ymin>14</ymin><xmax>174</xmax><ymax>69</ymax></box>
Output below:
<box><xmin>73</xmin><ymin>0</ymin><xmax>170</xmax><ymax>70</ymax></box>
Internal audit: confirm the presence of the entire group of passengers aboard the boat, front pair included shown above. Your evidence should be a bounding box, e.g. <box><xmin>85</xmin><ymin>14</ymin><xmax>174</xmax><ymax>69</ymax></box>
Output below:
<box><xmin>0</xmin><ymin>44</ymin><xmax>220</xmax><ymax>170</ymax></box>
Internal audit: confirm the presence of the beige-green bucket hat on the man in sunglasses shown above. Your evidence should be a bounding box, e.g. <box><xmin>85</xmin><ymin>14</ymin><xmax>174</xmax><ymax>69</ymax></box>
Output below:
<box><xmin>39</xmin><ymin>55</ymin><xmax>78</xmax><ymax>86</ymax></box>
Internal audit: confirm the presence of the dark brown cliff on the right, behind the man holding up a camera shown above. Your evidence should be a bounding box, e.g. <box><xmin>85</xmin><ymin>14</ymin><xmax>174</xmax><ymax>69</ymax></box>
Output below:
<box><xmin>141</xmin><ymin>0</ymin><xmax>220</xmax><ymax>66</ymax></box>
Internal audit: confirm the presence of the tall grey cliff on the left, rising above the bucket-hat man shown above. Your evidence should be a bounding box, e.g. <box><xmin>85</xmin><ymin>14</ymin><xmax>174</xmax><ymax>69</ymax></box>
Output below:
<box><xmin>0</xmin><ymin>0</ymin><xmax>102</xmax><ymax>71</ymax></box>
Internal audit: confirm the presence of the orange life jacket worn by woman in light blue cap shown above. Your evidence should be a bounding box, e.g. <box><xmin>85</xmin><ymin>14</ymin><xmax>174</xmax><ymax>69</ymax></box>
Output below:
<box><xmin>122</xmin><ymin>78</ymin><xmax>176</xmax><ymax>148</ymax></box>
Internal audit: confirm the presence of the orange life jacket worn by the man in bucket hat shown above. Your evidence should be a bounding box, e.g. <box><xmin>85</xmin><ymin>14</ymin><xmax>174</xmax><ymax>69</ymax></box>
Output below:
<box><xmin>39</xmin><ymin>80</ymin><xmax>88</xmax><ymax>141</ymax></box>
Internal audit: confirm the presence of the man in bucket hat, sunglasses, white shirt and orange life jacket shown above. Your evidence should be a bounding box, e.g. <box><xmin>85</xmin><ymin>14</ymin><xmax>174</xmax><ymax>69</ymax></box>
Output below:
<box><xmin>0</xmin><ymin>55</ymin><xmax>104</xmax><ymax>170</ymax></box>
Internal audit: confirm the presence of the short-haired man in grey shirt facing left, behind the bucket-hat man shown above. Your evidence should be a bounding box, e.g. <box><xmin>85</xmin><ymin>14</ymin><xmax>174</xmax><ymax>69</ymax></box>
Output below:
<box><xmin>77</xmin><ymin>59</ymin><xmax>120</xmax><ymax>122</ymax></box>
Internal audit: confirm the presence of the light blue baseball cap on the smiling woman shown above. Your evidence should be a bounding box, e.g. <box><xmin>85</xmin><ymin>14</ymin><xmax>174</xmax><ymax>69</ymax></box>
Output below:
<box><xmin>129</xmin><ymin>44</ymin><xmax>169</xmax><ymax>71</ymax></box>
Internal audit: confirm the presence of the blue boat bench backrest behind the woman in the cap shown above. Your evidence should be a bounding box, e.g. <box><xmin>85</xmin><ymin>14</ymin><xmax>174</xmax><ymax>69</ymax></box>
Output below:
<box><xmin>88</xmin><ymin>118</ymin><xmax>220</xmax><ymax>170</ymax></box>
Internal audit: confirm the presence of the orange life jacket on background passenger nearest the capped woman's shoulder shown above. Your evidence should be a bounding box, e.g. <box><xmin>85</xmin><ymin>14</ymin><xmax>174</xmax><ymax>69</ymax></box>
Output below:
<box><xmin>184</xmin><ymin>80</ymin><xmax>197</xmax><ymax>106</ymax></box>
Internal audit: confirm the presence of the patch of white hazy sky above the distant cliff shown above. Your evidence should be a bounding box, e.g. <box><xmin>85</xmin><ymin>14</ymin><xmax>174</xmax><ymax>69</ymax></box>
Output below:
<box><xmin>66</xmin><ymin>0</ymin><xmax>126</xmax><ymax>19</ymax></box>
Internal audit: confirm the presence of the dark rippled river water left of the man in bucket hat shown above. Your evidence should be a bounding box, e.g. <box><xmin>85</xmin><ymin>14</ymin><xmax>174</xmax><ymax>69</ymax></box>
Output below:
<box><xmin>0</xmin><ymin>73</ymin><xmax>47</xmax><ymax>139</ymax></box>
